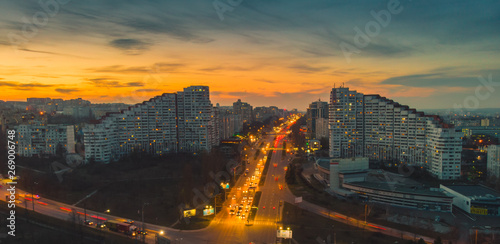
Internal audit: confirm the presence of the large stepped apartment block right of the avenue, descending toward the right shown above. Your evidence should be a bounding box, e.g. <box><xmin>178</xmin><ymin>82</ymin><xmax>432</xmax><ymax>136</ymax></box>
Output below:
<box><xmin>329</xmin><ymin>87</ymin><xmax>462</xmax><ymax>179</ymax></box>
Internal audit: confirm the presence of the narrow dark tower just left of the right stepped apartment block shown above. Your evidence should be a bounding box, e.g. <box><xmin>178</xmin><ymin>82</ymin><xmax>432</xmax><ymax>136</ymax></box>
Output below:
<box><xmin>306</xmin><ymin>100</ymin><xmax>328</xmax><ymax>140</ymax></box>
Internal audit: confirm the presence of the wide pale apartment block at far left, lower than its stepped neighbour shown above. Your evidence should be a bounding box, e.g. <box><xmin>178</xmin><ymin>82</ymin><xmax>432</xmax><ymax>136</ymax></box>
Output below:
<box><xmin>14</xmin><ymin>124</ymin><xmax>75</xmax><ymax>157</ymax></box>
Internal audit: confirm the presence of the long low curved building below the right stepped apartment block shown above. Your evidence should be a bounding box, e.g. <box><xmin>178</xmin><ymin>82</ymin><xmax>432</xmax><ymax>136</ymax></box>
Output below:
<box><xmin>315</xmin><ymin>157</ymin><xmax>453</xmax><ymax>212</ymax></box>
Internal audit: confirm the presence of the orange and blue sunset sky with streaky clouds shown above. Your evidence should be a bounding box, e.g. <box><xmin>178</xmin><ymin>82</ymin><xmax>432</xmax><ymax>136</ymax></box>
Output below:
<box><xmin>0</xmin><ymin>0</ymin><xmax>500</xmax><ymax>110</ymax></box>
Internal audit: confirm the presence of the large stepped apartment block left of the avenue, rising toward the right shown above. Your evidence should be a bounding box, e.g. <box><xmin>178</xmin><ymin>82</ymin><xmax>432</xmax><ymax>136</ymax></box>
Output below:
<box><xmin>83</xmin><ymin>86</ymin><xmax>218</xmax><ymax>163</ymax></box>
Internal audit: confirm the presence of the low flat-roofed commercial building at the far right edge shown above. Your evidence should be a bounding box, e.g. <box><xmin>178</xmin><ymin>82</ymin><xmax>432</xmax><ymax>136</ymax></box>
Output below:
<box><xmin>440</xmin><ymin>185</ymin><xmax>500</xmax><ymax>216</ymax></box>
